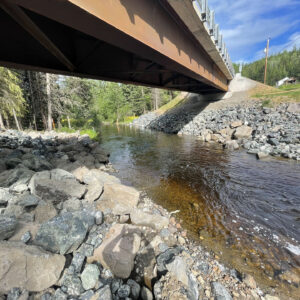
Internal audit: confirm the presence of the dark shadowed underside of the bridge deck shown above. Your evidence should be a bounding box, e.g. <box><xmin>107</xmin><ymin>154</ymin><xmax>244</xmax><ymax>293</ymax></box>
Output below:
<box><xmin>0</xmin><ymin>0</ymin><xmax>226</xmax><ymax>94</ymax></box>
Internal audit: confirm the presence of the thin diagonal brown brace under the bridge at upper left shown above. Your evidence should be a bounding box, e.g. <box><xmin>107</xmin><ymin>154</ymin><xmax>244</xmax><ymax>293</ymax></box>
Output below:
<box><xmin>0</xmin><ymin>0</ymin><xmax>75</xmax><ymax>71</ymax></box>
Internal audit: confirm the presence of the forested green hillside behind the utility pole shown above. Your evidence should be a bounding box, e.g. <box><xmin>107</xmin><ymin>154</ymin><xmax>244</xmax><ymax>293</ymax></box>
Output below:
<box><xmin>238</xmin><ymin>48</ymin><xmax>300</xmax><ymax>86</ymax></box>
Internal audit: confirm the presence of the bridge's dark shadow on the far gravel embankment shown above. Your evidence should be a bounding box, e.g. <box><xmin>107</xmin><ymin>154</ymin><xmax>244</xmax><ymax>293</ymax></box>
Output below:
<box><xmin>148</xmin><ymin>93</ymin><xmax>226</xmax><ymax>134</ymax></box>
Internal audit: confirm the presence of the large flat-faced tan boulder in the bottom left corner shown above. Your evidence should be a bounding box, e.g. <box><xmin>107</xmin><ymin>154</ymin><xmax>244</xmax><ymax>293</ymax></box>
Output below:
<box><xmin>0</xmin><ymin>242</ymin><xmax>65</xmax><ymax>293</ymax></box>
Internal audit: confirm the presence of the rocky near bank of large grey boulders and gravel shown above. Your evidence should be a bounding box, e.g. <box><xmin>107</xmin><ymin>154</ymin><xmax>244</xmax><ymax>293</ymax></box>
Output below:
<box><xmin>0</xmin><ymin>129</ymin><xmax>279</xmax><ymax>300</ymax></box>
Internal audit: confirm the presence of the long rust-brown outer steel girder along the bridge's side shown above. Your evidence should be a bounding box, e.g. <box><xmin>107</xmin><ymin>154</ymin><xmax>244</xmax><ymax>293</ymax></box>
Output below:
<box><xmin>11</xmin><ymin>0</ymin><xmax>228</xmax><ymax>91</ymax></box>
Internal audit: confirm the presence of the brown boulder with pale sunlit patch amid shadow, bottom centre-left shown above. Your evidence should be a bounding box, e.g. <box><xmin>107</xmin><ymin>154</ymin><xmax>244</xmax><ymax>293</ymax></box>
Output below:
<box><xmin>87</xmin><ymin>224</ymin><xmax>141</xmax><ymax>279</ymax></box>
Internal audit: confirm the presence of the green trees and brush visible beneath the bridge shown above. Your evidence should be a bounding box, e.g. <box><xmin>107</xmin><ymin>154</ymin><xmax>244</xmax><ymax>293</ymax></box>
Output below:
<box><xmin>0</xmin><ymin>68</ymin><xmax>178</xmax><ymax>131</ymax></box>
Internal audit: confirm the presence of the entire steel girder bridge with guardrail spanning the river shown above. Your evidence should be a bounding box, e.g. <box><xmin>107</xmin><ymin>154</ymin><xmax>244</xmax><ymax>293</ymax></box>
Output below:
<box><xmin>0</xmin><ymin>0</ymin><xmax>234</xmax><ymax>94</ymax></box>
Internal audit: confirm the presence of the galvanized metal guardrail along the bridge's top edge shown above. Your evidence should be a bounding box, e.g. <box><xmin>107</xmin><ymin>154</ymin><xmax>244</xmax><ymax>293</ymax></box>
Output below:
<box><xmin>193</xmin><ymin>0</ymin><xmax>235</xmax><ymax>77</ymax></box>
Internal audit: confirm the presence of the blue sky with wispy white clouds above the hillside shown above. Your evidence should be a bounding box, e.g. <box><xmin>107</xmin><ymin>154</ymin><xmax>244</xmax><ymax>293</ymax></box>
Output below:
<box><xmin>208</xmin><ymin>0</ymin><xmax>300</xmax><ymax>62</ymax></box>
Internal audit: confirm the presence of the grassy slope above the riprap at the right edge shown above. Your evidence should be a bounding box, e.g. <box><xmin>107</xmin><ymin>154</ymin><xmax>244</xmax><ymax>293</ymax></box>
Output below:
<box><xmin>251</xmin><ymin>84</ymin><xmax>300</xmax><ymax>107</ymax></box>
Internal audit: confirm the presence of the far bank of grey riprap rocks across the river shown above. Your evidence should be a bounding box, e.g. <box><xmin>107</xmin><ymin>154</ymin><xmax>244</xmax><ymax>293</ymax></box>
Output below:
<box><xmin>134</xmin><ymin>100</ymin><xmax>300</xmax><ymax>161</ymax></box>
